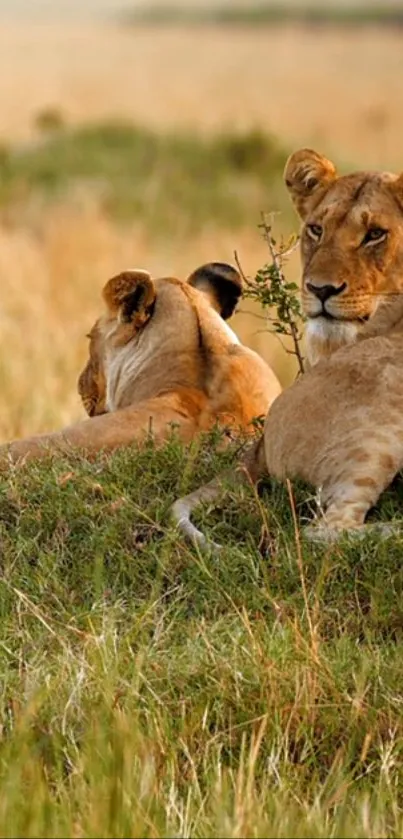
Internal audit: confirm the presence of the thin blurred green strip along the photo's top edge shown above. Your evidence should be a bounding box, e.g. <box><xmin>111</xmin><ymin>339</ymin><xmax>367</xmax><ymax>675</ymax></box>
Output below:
<box><xmin>121</xmin><ymin>2</ymin><xmax>403</xmax><ymax>27</ymax></box>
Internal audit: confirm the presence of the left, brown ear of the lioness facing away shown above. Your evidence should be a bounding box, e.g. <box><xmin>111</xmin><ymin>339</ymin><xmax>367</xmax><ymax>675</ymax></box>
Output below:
<box><xmin>102</xmin><ymin>269</ymin><xmax>155</xmax><ymax>327</ymax></box>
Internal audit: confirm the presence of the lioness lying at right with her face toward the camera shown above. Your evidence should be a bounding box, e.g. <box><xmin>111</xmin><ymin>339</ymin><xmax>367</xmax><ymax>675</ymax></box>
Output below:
<box><xmin>173</xmin><ymin>149</ymin><xmax>403</xmax><ymax>544</ymax></box>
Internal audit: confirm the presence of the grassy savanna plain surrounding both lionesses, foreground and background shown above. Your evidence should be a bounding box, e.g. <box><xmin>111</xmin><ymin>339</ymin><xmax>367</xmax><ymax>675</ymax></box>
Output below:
<box><xmin>0</xmin><ymin>8</ymin><xmax>403</xmax><ymax>837</ymax></box>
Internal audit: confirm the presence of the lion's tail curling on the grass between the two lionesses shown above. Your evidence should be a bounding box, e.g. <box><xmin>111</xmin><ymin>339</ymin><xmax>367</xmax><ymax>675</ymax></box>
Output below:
<box><xmin>171</xmin><ymin>437</ymin><xmax>266</xmax><ymax>548</ymax></box>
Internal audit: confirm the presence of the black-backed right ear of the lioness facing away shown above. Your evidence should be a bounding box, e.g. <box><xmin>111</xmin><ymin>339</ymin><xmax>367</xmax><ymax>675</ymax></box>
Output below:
<box><xmin>188</xmin><ymin>262</ymin><xmax>242</xmax><ymax>320</ymax></box>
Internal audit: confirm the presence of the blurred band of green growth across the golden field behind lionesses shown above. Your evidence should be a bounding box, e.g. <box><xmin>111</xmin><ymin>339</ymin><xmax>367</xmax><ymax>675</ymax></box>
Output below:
<box><xmin>0</xmin><ymin>121</ymin><xmax>286</xmax><ymax>235</ymax></box>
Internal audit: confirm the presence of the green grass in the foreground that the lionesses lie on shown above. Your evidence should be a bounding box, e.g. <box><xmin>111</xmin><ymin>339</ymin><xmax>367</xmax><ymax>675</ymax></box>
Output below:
<box><xmin>0</xmin><ymin>435</ymin><xmax>403</xmax><ymax>837</ymax></box>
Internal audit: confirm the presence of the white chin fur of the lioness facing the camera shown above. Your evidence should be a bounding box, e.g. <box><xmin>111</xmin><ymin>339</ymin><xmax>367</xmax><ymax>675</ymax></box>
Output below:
<box><xmin>305</xmin><ymin>318</ymin><xmax>360</xmax><ymax>366</ymax></box>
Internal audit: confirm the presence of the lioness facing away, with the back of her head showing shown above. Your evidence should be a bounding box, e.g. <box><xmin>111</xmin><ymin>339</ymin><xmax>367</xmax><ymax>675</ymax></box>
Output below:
<box><xmin>0</xmin><ymin>262</ymin><xmax>281</xmax><ymax>465</ymax></box>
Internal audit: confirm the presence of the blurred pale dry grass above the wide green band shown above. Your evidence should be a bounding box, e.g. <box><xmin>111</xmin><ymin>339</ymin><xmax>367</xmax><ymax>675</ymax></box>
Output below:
<box><xmin>0</xmin><ymin>24</ymin><xmax>403</xmax><ymax>166</ymax></box>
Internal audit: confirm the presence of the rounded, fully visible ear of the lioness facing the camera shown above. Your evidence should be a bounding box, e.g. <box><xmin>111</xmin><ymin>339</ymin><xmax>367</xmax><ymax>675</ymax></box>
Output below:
<box><xmin>284</xmin><ymin>149</ymin><xmax>336</xmax><ymax>220</ymax></box>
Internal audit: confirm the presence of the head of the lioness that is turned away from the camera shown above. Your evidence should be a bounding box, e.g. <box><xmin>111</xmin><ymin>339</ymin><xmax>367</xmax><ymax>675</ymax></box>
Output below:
<box><xmin>78</xmin><ymin>262</ymin><xmax>242</xmax><ymax>417</ymax></box>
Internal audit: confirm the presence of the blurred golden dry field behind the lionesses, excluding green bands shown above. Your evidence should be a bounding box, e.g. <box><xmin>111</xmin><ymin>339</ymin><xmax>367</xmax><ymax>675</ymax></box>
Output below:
<box><xmin>0</xmin><ymin>21</ymin><xmax>403</xmax><ymax>440</ymax></box>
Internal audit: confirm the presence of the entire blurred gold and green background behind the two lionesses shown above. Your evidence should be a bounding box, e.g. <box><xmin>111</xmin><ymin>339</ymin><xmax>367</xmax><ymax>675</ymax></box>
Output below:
<box><xmin>0</xmin><ymin>0</ymin><xmax>403</xmax><ymax>440</ymax></box>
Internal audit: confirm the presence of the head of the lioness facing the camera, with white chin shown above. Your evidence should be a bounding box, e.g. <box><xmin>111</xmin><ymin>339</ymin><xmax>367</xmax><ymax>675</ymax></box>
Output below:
<box><xmin>284</xmin><ymin>149</ymin><xmax>403</xmax><ymax>364</ymax></box>
